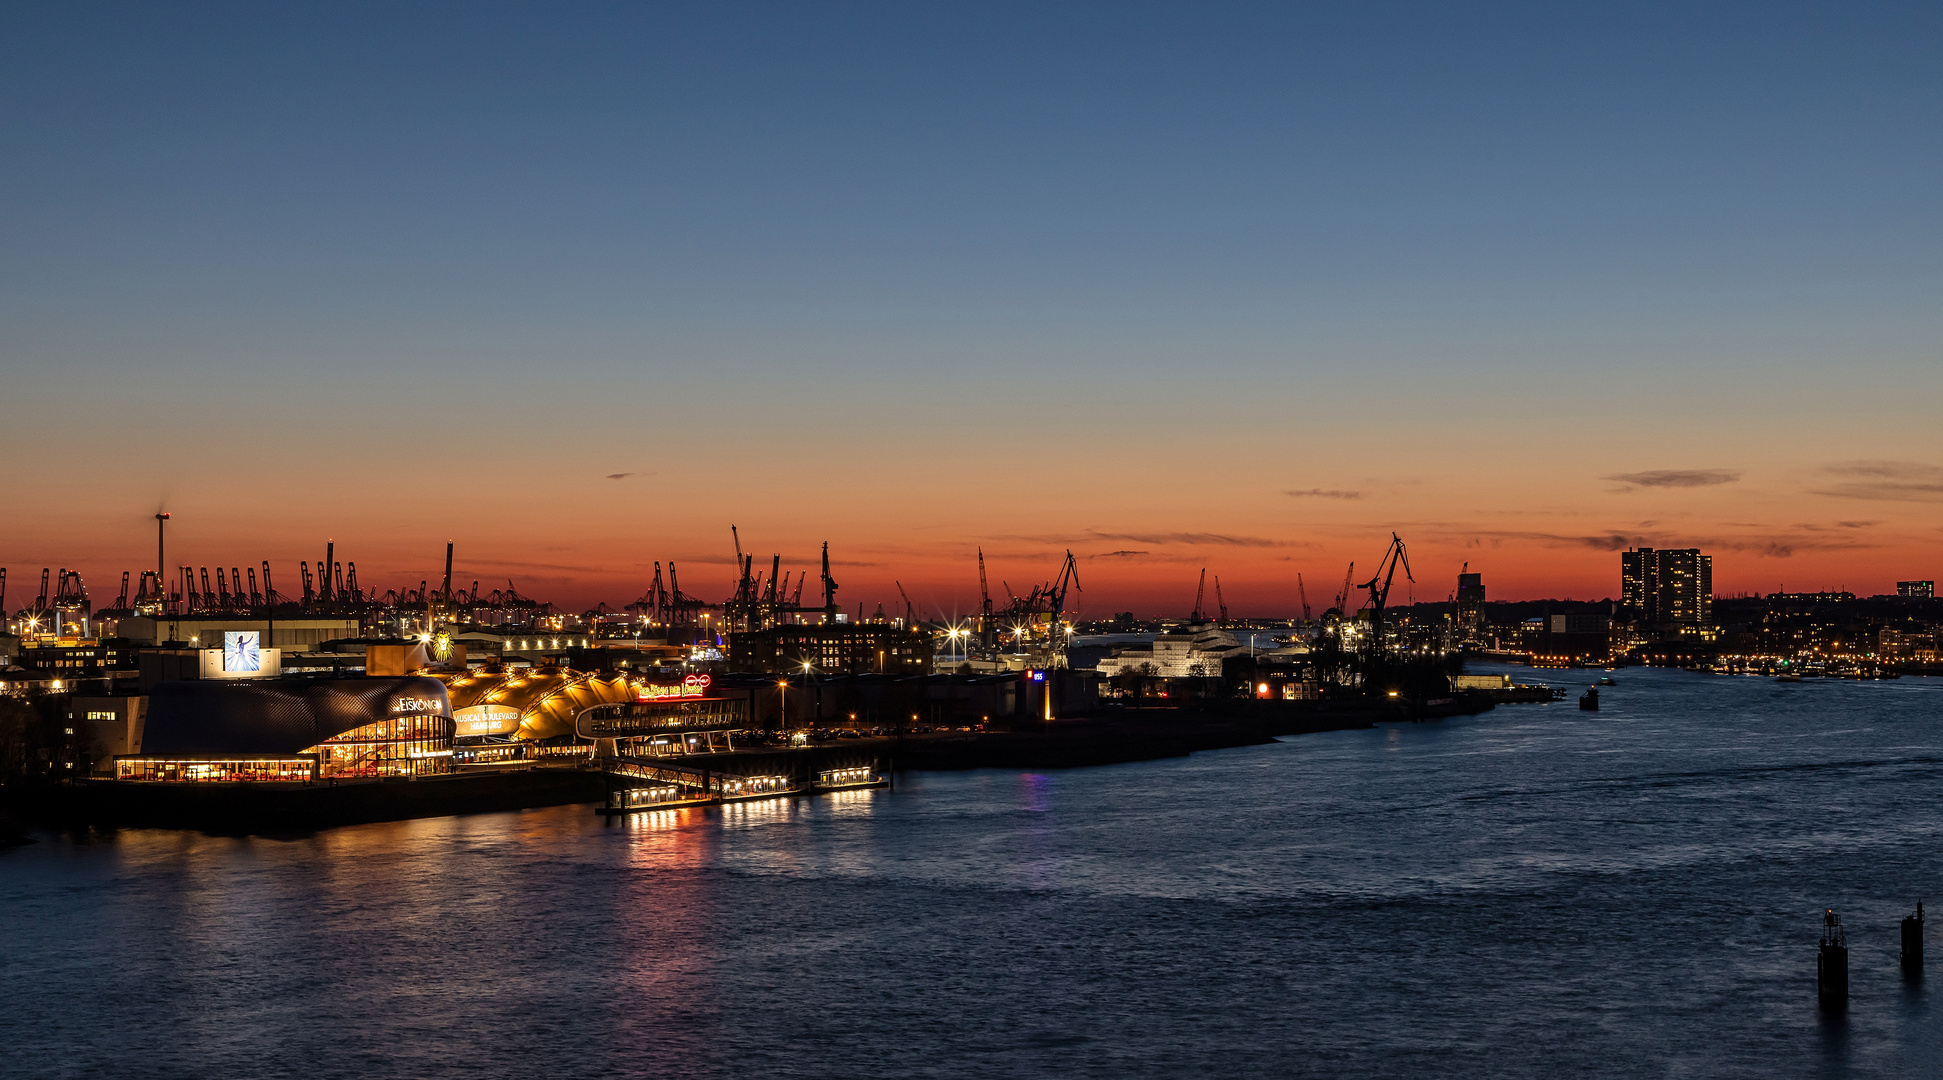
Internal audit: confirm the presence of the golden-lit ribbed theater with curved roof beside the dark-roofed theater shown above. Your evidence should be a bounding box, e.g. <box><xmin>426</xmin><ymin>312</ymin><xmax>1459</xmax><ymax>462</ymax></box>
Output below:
<box><xmin>443</xmin><ymin>668</ymin><xmax>748</xmax><ymax>765</ymax></box>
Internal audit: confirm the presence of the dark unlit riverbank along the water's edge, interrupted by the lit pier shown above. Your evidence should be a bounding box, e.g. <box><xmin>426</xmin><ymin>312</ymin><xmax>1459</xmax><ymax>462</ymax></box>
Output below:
<box><xmin>0</xmin><ymin>697</ymin><xmax>1492</xmax><ymax>837</ymax></box>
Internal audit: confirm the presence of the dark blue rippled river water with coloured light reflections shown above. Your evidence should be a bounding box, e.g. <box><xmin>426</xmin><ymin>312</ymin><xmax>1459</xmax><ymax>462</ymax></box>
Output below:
<box><xmin>0</xmin><ymin>668</ymin><xmax>1943</xmax><ymax>1078</ymax></box>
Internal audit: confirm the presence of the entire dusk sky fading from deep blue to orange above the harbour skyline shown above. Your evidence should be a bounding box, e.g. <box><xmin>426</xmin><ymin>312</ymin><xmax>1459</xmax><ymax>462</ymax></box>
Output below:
<box><xmin>0</xmin><ymin>2</ymin><xmax>1943</xmax><ymax>616</ymax></box>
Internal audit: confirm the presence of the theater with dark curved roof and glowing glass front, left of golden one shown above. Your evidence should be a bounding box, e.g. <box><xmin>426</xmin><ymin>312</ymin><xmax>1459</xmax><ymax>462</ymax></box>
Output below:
<box><xmin>115</xmin><ymin>676</ymin><xmax>453</xmax><ymax>781</ymax></box>
